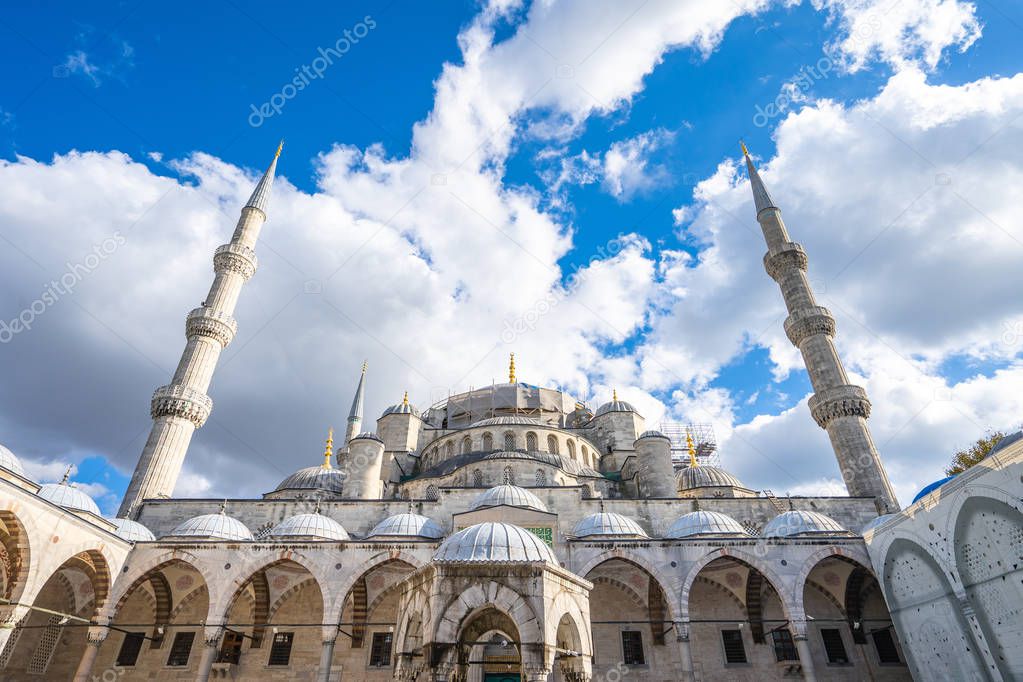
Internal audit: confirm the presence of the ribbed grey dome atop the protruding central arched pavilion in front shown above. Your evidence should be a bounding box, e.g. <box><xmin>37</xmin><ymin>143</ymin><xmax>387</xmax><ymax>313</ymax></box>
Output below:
<box><xmin>434</xmin><ymin>522</ymin><xmax>558</xmax><ymax>565</ymax></box>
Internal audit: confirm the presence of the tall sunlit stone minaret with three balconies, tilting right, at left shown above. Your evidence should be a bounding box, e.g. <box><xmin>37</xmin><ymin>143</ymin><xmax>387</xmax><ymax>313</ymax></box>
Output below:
<box><xmin>118</xmin><ymin>142</ymin><xmax>283</xmax><ymax>518</ymax></box>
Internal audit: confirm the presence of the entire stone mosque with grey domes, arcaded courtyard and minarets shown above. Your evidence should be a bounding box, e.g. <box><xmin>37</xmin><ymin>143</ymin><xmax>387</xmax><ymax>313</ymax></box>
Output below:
<box><xmin>0</xmin><ymin>141</ymin><xmax>1023</xmax><ymax>682</ymax></box>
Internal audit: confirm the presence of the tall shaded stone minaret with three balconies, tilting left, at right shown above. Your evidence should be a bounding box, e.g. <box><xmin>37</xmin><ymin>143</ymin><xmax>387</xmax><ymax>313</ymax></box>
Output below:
<box><xmin>743</xmin><ymin>144</ymin><xmax>898</xmax><ymax>512</ymax></box>
